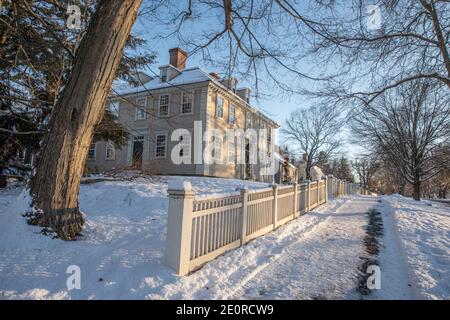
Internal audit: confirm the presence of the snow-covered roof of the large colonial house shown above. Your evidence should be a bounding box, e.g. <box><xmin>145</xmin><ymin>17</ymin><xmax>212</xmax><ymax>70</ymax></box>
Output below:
<box><xmin>111</xmin><ymin>67</ymin><xmax>280</xmax><ymax>127</ymax></box>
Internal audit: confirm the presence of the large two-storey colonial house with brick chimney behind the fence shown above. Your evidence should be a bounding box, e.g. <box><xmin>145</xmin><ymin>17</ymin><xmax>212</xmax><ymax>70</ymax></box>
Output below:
<box><xmin>87</xmin><ymin>48</ymin><xmax>279</xmax><ymax>181</ymax></box>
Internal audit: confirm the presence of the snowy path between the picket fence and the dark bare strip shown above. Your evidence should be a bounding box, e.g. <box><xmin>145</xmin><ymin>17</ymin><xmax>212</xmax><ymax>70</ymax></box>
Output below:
<box><xmin>229</xmin><ymin>198</ymin><xmax>378</xmax><ymax>299</ymax></box>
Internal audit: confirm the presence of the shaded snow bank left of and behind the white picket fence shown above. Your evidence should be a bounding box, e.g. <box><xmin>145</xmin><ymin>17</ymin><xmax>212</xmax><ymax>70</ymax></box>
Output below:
<box><xmin>0</xmin><ymin>176</ymin><xmax>268</xmax><ymax>299</ymax></box>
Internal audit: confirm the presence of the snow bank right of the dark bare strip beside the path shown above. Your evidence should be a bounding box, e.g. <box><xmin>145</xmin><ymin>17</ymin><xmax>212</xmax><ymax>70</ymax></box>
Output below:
<box><xmin>383</xmin><ymin>195</ymin><xmax>450</xmax><ymax>299</ymax></box>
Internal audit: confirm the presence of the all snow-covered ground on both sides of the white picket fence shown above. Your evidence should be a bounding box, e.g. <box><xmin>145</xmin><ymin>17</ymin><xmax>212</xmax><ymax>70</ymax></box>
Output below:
<box><xmin>0</xmin><ymin>177</ymin><xmax>450</xmax><ymax>299</ymax></box>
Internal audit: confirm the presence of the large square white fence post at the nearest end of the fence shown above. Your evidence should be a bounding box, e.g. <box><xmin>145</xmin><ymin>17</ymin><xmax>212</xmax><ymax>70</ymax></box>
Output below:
<box><xmin>166</xmin><ymin>181</ymin><xmax>194</xmax><ymax>276</ymax></box>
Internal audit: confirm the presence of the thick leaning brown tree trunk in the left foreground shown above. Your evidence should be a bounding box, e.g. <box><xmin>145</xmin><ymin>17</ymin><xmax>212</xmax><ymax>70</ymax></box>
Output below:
<box><xmin>31</xmin><ymin>0</ymin><xmax>142</xmax><ymax>240</ymax></box>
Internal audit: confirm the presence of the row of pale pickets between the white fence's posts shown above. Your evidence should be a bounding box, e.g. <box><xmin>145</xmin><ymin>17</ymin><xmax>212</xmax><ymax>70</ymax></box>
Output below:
<box><xmin>190</xmin><ymin>180</ymin><xmax>326</xmax><ymax>265</ymax></box>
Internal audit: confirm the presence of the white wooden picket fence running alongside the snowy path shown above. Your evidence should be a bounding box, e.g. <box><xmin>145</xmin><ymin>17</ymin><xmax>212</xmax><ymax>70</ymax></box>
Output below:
<box><xmin>166</xmin><ymin>176</ymin><xmax>365</xmax><ymax>275</ymax></box>
